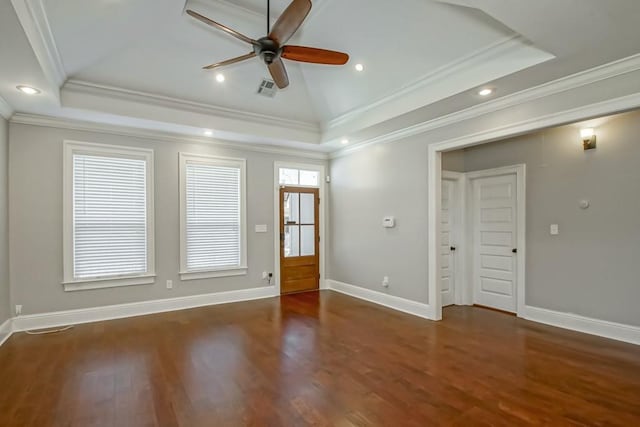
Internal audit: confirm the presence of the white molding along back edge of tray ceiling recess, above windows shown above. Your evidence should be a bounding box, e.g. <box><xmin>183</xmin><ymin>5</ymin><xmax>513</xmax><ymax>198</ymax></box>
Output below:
<box><xmin>62</xmin><ymin>80</ymin><xmax>320</xmax><ymax>132</ymax></box>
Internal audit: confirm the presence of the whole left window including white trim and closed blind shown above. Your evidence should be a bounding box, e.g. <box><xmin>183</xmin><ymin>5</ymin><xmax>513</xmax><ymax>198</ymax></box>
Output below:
<box><xmin>64</xmin><ymin>142</ymin><xmax>154</xmax><ymax>291</ymax></box>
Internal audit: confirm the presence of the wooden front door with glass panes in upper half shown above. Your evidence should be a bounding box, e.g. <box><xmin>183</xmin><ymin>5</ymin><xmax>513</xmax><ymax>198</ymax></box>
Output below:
<box><xmin>280</xmin><ymin>187</ymin><xmax>320</xmax><ymax>294</ymax></box>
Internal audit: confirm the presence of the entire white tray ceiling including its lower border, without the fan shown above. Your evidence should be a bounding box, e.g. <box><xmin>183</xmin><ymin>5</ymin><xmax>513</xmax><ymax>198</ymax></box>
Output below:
<box><xmin>0</xmin><ymin>0</ymin><xmax>640</xmax><ymax>151</ymax></box>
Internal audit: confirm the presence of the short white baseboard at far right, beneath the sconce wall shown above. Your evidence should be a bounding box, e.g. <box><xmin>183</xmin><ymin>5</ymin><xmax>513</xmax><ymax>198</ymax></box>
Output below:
<box><xmin>522</xmin><ymin>305</ymin><xmax>640</xmax><ymax>345</ymax></box>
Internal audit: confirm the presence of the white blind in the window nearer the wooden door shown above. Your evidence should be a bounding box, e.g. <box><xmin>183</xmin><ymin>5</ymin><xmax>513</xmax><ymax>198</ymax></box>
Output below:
<box><xmin>184</xmin><ymin>161</ymin><xmax>243</xmax><ymax>272</ymax></box>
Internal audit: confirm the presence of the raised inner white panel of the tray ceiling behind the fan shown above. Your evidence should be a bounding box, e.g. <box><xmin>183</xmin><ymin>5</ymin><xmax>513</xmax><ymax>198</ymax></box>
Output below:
<box><xmin>44</xmin><ymin>0</ymin><xmax>548</xmax><ymax>123</ymax></box>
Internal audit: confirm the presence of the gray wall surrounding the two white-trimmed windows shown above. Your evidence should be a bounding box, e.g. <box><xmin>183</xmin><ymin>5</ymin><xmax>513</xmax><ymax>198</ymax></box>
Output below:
<box><xmin>9</xmin><ymin>123</ymin><xmax>322</xmax><ymax>314</ymax></box>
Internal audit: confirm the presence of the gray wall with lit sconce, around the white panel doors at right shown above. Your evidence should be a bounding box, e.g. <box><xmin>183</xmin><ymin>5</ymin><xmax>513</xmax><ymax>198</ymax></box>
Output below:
<box><xmin>454</xmin><ymin>112</ymin><xmax>640</xmax><ymax>326</ymax></box>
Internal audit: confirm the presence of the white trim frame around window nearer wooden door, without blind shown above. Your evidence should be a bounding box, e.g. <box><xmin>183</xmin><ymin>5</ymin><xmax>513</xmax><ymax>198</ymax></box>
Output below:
<box><xmin>179</xmin><ymin>152</ymin><xmax>249</xmax><ymax>280</ymax></box>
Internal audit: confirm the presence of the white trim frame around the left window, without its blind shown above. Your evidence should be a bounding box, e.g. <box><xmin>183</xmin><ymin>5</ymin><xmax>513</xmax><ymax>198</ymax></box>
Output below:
<box><xmin>62</xmin><ymin>140</ymin><xmax>156</xmax><ymax>292</ymax></box>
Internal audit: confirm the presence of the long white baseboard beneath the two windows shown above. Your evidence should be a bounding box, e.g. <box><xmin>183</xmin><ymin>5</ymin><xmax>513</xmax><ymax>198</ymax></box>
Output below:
<box><xmin>12</xmin><ymin>286</ymin><xmax>278</xmax><ymax>332</ymax></box>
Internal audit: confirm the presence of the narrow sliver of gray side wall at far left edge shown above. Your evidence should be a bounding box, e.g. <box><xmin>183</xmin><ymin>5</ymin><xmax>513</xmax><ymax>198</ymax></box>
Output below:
<box><xmin>0</xmin><ymin>117</ymin><xmax>11</xmax><ymax>324</ymax></box>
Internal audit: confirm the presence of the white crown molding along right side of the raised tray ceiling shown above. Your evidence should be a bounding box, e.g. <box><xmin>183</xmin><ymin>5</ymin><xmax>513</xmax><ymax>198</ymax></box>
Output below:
<box><xmin>323</xmin><ymin>35</ymin><xmax>530</xmax><ymax>132</ymax></box>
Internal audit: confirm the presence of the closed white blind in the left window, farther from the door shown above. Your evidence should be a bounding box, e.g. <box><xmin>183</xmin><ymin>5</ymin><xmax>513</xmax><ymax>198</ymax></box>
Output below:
<box><xmin>72</xmin><ymin>154</ymin><xmax>148</xmax><ymax>280</ymax></box>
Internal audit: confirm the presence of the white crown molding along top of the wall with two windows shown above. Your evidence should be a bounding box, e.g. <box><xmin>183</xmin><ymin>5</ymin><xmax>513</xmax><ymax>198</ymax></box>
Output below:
<box><xmin>11</xmin><ymin>113</ymin><xmax>329</xmax><ymax>160</ymax></box>
